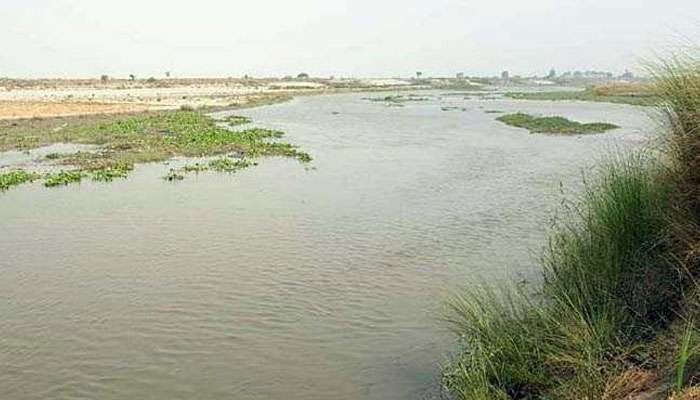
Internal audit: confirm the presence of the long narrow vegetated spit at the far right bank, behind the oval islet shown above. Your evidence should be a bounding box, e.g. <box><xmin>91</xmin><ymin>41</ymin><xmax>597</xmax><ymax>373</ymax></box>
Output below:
<box><xmin>505</xmin><ymin>85</ymin><xmax>661</xmax><ymax>106</ymax></box>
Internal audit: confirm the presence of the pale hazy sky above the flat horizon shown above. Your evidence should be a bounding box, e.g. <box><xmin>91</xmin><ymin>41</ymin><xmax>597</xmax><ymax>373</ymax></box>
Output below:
<box><xmin>0</xmin><ymin>0</ymin><xmax>700</xmax><ymax>77</ymax></box>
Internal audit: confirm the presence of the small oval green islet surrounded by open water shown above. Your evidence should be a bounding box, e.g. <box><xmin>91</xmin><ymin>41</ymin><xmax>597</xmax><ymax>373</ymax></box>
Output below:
<box><xmin>496</xmin><ymin>113</ymin><xmax>619</xmax><ymax>135</ymax></box>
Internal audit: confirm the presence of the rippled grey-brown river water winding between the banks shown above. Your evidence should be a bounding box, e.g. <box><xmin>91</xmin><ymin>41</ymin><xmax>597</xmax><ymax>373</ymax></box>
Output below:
<box><xmin>0</xmin><ymin>93</ymin><xmax>654</xmax><ymax>400</ymax></box>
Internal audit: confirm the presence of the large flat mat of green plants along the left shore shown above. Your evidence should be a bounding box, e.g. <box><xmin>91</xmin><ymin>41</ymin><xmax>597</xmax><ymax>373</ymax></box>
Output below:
<box><xmin>0</xmin><ymin>110</ymin><xmax>312</xmax><ymax>190</ymax></box>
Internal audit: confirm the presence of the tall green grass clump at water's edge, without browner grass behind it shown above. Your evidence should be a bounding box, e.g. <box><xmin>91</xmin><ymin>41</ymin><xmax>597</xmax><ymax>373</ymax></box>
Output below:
<box><xmin>445</xmin><ymin>156</ymin><xmax>679</xmax><ymax>399</ymax></box>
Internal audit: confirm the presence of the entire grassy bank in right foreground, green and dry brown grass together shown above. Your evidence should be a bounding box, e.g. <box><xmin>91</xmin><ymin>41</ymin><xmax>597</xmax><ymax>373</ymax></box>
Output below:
<box><xmin>443</xmin><ymin>54</ymin><xmax>700</xmax><ymax>400</ymax></box>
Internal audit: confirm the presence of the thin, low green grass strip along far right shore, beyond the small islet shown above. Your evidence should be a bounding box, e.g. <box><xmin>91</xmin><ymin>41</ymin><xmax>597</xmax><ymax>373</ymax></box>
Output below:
<box><xmin>505</xmin><ymin>88</ymin><xmax>661</xmax><ymax>106</ymax></box>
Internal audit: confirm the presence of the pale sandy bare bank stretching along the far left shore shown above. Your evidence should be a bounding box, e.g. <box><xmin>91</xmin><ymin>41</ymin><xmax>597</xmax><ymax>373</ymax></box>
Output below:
<box><xmin>0</xmin><ymin>79</ymin><xmax>418</xmax><ymax>119</ymax></box>
